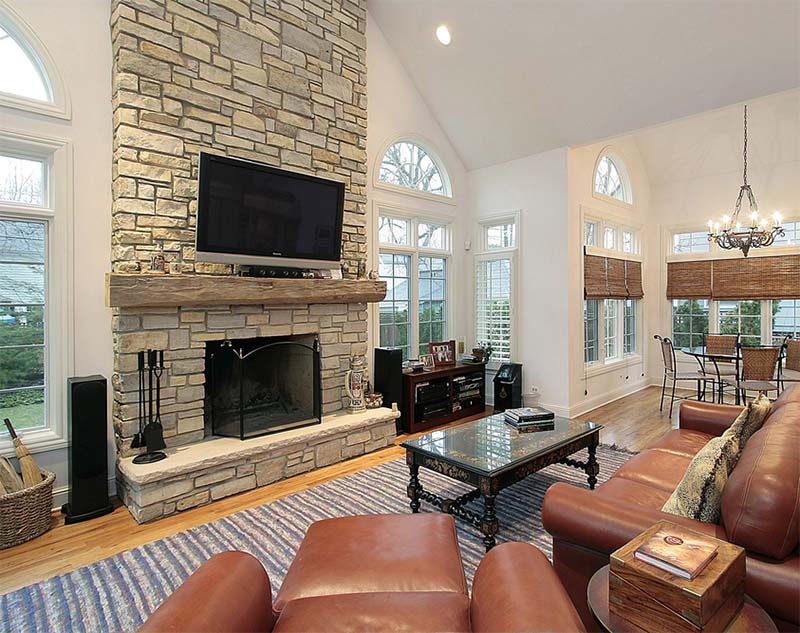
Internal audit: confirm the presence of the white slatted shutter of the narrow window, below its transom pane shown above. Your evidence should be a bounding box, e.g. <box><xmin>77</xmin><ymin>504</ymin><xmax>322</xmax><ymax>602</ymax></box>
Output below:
<box><xmin>475</xmin><ymin>257</ymin><xmax>513</xmax><ymax>362</ymax></box>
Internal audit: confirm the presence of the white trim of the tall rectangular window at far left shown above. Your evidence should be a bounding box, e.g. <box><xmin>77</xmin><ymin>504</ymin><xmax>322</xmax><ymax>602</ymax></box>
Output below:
<box><xmin>0</xmin><ymin>129</ymin><xmax>75</xmax><ymax>455</ymax></box>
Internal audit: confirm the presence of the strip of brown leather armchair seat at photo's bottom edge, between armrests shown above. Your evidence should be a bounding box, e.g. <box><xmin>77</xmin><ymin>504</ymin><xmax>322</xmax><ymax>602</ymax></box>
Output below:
<box><xmin>273</xmin><ymin>591</ymin><xmax>470</xmax><ymax>633</ymax></box>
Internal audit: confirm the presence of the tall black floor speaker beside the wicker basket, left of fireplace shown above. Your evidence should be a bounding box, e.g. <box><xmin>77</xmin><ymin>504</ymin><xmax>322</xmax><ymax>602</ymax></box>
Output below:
<box><xmin>61</xmin><ymin>376</ymin><xmax>114</xmax><ymax>523</ymax></box>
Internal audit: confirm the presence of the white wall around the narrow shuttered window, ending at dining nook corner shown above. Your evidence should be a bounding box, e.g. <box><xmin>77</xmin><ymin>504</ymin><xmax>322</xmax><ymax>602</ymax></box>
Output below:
<box><xmin>468</xmin><ymin>148</ymin><xmax>570</xmax><ymax>414</ymax></box>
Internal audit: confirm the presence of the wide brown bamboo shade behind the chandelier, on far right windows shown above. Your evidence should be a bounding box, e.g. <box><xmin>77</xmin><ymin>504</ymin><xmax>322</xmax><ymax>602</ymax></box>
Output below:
<box><xmin>667</xmin><ymin>255</ymin><xmax>800</xmax><ymax>301</ymax></box>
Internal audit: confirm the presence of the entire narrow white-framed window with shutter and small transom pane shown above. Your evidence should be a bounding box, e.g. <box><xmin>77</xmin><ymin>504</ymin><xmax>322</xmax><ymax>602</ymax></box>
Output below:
<box><xmin>475</xmin><ymin>217</ymin><xmax>517</xmax><ymax>364</ymax></box>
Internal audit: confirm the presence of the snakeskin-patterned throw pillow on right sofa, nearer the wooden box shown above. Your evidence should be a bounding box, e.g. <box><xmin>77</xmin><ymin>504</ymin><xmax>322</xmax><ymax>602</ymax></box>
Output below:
<box><xmin>661</xmin><ymin>433</ymin><xmax>739</xmax><ymax>523</ymax></box>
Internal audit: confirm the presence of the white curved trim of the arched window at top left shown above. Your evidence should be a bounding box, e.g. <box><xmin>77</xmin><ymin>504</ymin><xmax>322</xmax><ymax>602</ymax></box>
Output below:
<box><xmin>0</xmin><ymin>2</ymin><xmax>72</xmax><ymax>120</ymax></box>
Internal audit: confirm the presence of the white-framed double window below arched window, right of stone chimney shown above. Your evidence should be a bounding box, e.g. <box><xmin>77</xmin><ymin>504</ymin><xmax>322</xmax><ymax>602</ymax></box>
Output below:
<box><xmin>378</xmin><ymin>213</ymin><xmax>450</xmax><ymax>360</ymax></box>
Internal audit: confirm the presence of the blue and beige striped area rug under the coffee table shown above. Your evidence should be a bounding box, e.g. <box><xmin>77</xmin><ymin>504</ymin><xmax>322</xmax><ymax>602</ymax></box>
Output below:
<box><xmin>0</xmin><ymin>446</ymin><xmax>631</xmax><ymax>632</ymax></box>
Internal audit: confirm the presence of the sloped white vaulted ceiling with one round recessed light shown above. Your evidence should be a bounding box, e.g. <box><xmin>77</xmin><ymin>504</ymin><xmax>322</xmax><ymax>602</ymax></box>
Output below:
<box><xmin>369</xmin><ymin>0</ymin><xmax>800</xmax><ymax>169</ymax></box>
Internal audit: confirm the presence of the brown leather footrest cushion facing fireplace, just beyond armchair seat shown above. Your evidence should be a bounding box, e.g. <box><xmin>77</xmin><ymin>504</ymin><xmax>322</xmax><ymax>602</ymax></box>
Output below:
<box><xmin>274</xmin><ymin>513</ymin><xmax>467</xmax><ymax>611</ymax></box>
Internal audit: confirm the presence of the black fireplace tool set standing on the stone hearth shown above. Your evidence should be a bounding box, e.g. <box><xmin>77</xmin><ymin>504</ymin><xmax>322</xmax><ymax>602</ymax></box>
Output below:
<box><xmin>131</xmin><ymin>349</ymin><xmax>167</xmax><ymax>464</ymax></box>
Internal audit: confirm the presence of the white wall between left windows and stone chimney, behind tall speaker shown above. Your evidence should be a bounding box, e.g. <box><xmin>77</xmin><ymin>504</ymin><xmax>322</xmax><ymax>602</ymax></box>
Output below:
<box><xmin>0</xmin><ymin>0</ymin><xmax>114</xmax><ymax>505</ymax></box>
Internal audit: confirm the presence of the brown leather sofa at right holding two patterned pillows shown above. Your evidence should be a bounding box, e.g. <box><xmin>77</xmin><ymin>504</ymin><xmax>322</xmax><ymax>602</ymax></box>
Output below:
<box><xmin>542</xmin><ymin>387</ymin><xmax>800</xmax><ymax>631</ymax></box>
